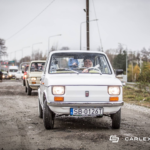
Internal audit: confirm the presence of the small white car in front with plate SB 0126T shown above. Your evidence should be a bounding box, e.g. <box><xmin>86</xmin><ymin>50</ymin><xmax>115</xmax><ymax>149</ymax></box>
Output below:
<box><xmin>38</xmin><ymin>50</ymin><xmax>123</xmax><ymax>129</ymax></box>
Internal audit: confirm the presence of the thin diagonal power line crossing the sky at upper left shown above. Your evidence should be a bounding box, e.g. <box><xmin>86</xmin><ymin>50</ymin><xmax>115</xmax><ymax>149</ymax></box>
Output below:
<box><xmin>6</xmin><ymin>0</ymin><xmax>55</xmax><ymax>40</ymax></box>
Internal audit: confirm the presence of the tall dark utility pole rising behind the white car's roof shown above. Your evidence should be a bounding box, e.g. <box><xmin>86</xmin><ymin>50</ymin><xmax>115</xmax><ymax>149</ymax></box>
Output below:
<box><xmin>86</xmin><ymin>0</ymin><xmax>90</xmax><ymax>51</ymax></box>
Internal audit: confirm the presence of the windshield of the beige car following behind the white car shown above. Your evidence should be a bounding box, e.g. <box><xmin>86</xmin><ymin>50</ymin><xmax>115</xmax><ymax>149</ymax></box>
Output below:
<box><xmin>30</xmin><ymin>62</ymin><xmax>45</xmax><ymax>72</ymax></box>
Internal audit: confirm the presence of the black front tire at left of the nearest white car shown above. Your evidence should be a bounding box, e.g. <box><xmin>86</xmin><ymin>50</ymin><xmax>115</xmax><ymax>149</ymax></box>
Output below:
<box><xmin>43</xmin><ymin>100</ymin><xmax>54</xmax><ymax>130</ymax></box>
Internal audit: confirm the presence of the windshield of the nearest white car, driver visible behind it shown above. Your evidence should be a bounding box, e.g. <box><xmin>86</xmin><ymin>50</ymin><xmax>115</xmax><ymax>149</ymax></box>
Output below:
<box><xmin>49</xmin><ymin>52</ymin><xmax>112</xmax><ymax>74</ymax></box>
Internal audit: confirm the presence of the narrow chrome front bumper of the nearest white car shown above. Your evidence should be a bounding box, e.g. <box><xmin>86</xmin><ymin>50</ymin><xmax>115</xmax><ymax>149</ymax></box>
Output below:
<box><xmin>47</xmin><ymin>102</ymin><xmax>124</xmax><ymax>107</ymax></box>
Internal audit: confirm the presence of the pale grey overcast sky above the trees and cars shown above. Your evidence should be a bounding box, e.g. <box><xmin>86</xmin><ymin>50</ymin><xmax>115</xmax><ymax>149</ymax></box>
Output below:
<box><xmin>0</xmin><ymin>0</ymin><xmax>150</xmax><ymax>59</ymax></box>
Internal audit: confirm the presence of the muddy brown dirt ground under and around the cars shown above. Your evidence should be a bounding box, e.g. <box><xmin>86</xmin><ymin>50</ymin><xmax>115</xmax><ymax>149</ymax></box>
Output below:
<box><xmin>0</xmin><ymin>80</ymin><xmax>150</xmax><ymax>150</ymax></box>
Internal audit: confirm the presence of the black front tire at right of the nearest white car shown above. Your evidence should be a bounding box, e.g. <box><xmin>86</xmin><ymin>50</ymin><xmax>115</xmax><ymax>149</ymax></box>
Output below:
<box><xmin>111</xmin><ymin>109</ymin><xmax>121</xmax><ymax>129</ymax></box>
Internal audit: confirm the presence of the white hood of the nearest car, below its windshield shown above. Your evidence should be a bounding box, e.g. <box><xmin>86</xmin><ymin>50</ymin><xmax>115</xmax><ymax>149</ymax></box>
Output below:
<box><xmin>44</xmin><ymin>74</ymin><xmax>122</xmax><ymax>86</ymax></box>
